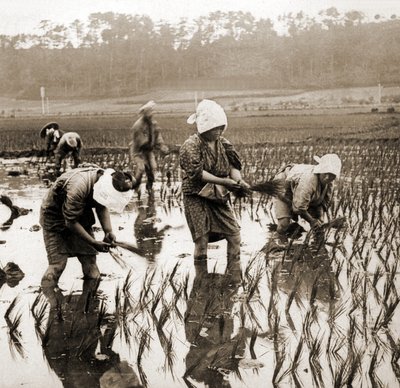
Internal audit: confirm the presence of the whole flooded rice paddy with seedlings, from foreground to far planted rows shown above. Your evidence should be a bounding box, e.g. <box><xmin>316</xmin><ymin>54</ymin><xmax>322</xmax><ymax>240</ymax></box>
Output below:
<box><xmin>0</xmin><ymin>110</ymin><xmax>400</xmax><ymax>387</ymax></box>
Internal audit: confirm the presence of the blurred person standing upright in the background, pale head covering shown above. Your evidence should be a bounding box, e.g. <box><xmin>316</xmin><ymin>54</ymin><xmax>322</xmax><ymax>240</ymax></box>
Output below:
<box><xmin>130</xmin><ymin>101</ymin><xmax>169</xmax><ymax>194</ymax></box>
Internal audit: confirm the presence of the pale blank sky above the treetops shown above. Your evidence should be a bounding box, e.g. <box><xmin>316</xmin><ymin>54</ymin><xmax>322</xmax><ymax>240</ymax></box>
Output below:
<box><xmin>0</xmin><ymin>0</ymin><xmax>400</xmax><ymax>35</ymax></box>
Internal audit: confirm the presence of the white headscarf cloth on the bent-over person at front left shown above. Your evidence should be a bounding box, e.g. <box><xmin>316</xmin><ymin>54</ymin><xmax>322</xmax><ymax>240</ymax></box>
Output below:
<box><xmin>93</xmin><ymin>168</ymin><xmax>133</xmax><ymax>213</ymax></box>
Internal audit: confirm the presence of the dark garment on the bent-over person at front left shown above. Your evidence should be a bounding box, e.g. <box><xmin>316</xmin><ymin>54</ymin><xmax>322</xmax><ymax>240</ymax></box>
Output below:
<box><xmin>40</xmin><ymin>168</ymin><xmax>102</xmax><ymax>261</ymax></box>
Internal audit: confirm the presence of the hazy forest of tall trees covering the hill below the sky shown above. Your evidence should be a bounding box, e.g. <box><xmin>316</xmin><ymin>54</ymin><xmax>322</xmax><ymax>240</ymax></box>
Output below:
<box><xmin>0</xmin><ymin>8</ymin><xmax>400</xmax><ymax>99</ymax></box>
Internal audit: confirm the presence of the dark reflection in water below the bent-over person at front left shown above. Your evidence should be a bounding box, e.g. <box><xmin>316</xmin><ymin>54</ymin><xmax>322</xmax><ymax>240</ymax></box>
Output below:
<box><xmin>43</xmin><ymin>280</ymin><xmax>141</xmax><ymax>388</ymax></box>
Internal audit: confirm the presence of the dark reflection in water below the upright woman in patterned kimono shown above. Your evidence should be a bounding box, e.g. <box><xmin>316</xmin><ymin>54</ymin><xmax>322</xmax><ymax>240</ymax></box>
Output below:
<box><xmin>185</xmin><ymin>262</ymin><xmax>245</xmax><ymax>387</ymax></box>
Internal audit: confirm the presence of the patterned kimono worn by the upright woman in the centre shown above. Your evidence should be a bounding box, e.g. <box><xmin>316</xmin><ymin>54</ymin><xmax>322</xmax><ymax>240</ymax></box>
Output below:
<box><xmin>179</xmin><ymin>134</ymin><xmax>241</xmax><ymax>242</ymax></box>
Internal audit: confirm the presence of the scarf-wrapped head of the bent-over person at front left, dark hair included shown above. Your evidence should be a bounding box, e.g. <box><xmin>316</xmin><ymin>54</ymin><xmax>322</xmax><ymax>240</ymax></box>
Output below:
<box><xmin>93</xmin><ymin>168</ymin><xmax>136</xmax><ymax>213</ymax></box>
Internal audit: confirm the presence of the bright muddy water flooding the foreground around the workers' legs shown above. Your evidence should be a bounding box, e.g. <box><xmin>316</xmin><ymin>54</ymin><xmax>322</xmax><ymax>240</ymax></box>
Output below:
<box><xmin>0</xmin><ymin>161</ymin><xmax>400</xmax><ymax>387</ymax></box>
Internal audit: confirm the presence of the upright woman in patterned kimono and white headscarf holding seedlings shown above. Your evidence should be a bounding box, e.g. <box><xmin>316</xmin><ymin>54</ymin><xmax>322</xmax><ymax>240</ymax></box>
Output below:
<box><xmin>179</xmin><ymin>100</ymin><xmax>249</xmax><ymax>276</ymax></box>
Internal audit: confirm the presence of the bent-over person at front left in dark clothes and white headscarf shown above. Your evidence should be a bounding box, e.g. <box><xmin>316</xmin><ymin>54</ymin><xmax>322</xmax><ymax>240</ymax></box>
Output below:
<box><xmin>40</xmin><ymin>168</ymin><xmax>135</xmax><ymax>287</ymax></box>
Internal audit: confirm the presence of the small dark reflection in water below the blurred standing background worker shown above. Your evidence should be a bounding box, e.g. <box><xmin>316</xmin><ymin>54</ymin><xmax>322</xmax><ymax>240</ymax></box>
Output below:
<box><xmin>134</xmin><ymin>196</ymin><xmax>168</xmax><ymax>260</ymax></box>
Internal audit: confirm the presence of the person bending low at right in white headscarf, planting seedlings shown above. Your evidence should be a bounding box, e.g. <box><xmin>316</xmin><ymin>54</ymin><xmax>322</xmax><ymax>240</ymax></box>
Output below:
<box><xmin>270</xmin><ymin>154</ymin><xmax>342</xmax><ymax>249</ymax></box>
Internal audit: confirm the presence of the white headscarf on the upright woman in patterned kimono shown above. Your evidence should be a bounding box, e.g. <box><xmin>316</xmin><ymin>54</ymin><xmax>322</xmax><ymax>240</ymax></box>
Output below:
<box><xmin>187</xmin><ymin>100</ymin><xmax>228</xmax><ymax>133</ymax></box>
